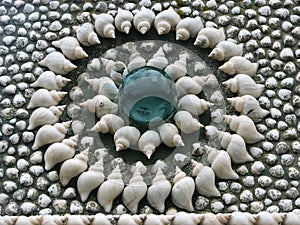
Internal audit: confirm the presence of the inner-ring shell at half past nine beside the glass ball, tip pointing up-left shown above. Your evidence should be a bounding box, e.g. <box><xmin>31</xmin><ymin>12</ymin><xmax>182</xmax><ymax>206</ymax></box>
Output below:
<box><xmin>85</xmin><ymin>77</ymin><xmax>119</xmax><ymax>100</ymax></box>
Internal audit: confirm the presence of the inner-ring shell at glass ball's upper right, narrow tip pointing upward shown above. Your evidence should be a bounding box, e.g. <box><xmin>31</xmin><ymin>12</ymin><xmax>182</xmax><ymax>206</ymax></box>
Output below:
<box><xmin>165</xmin><ymin>54</ymin><xmax>187</xmax><ymax>81</ymax></box>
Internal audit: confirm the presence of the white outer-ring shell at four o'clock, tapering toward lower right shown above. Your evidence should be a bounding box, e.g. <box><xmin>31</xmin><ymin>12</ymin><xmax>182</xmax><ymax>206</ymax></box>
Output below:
<box><xmin>207</xmin><ymin>148</ymin><xmax>239</xmax><ymax>180</ymax></box>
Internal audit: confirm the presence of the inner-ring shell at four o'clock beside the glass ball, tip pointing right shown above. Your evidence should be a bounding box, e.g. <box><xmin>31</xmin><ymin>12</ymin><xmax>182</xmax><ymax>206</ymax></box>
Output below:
<box><xmin>174</xmin><ymin>111</ymin><xmax>203</xmax><ymax>134</ymax></box>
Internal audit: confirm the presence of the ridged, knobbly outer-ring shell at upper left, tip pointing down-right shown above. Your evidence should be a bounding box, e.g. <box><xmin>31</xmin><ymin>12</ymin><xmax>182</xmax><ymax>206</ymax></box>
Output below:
<box><xmin>73</xmin><ymin>23</ymin><xmax>101</xmax><ymax>47</ymax></box>
